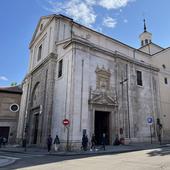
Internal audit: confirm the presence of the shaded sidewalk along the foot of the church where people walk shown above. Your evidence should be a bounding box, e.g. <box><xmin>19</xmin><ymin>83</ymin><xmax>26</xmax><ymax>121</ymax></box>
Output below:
<box><xmin>0</xmin><ymin>143</ymin><xmax>170</xmax><ymax>156</ymax></box>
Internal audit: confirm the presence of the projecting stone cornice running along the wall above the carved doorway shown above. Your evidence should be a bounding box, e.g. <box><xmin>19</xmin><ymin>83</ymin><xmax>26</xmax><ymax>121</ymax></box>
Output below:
<box><xmin>63</xmin><ymin>38</ymin><xmax>159</xmax><ymax>72</ymax></box>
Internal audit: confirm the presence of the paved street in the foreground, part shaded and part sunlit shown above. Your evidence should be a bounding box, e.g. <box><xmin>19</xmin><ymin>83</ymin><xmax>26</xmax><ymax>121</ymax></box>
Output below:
<box><xmin>0</xmin><ymin>147</ymin><xmax>170</xmax><ymax>170</ymax></box>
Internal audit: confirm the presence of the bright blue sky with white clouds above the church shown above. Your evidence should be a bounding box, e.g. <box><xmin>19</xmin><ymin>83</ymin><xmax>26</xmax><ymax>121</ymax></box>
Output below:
<box><xmin>0</xmin><ymin>0</ymin><xmax>170</xmax><ymax>86</ymax></box>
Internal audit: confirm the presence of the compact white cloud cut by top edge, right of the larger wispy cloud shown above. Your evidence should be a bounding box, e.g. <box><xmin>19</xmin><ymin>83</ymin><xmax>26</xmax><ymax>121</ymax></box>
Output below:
<box><xmin>99</xmin><ymin>0</ymin><xmax>132</xmax><ymax>9</ymax></box>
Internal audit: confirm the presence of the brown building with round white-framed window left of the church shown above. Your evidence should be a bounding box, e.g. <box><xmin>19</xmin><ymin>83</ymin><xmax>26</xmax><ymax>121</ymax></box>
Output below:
<box><xmin>0</xmin><ymin>86</ymin><xmax>22</xmax><ymax>144</ymax></box>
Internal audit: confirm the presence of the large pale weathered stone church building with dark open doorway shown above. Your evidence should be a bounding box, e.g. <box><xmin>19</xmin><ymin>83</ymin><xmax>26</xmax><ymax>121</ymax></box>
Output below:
<box><xmin>17</xmin><ymin>15</ymin><xmax>169</xmax><ymax>148</ymax></box>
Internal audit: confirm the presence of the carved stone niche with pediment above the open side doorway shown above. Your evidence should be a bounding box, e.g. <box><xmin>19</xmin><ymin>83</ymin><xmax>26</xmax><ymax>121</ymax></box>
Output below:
<box><xmin>89</xmin><ymin>66</ymin><xmax>117</xmax><ymax>106</ymax></box>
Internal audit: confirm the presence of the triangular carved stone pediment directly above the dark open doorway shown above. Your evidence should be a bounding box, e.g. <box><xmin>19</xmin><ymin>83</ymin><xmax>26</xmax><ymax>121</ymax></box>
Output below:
<box><xmin>90</xmin><ymin>93</ymin><xmax>117</xmax><ymax>106</ymax></box>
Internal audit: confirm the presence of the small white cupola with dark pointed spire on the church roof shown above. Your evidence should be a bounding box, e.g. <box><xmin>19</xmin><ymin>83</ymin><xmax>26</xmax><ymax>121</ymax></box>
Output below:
<box><xmin>139</xmin><ymin>19</ymin><xmax>152</xmax><ymax>47</ymax></box>
